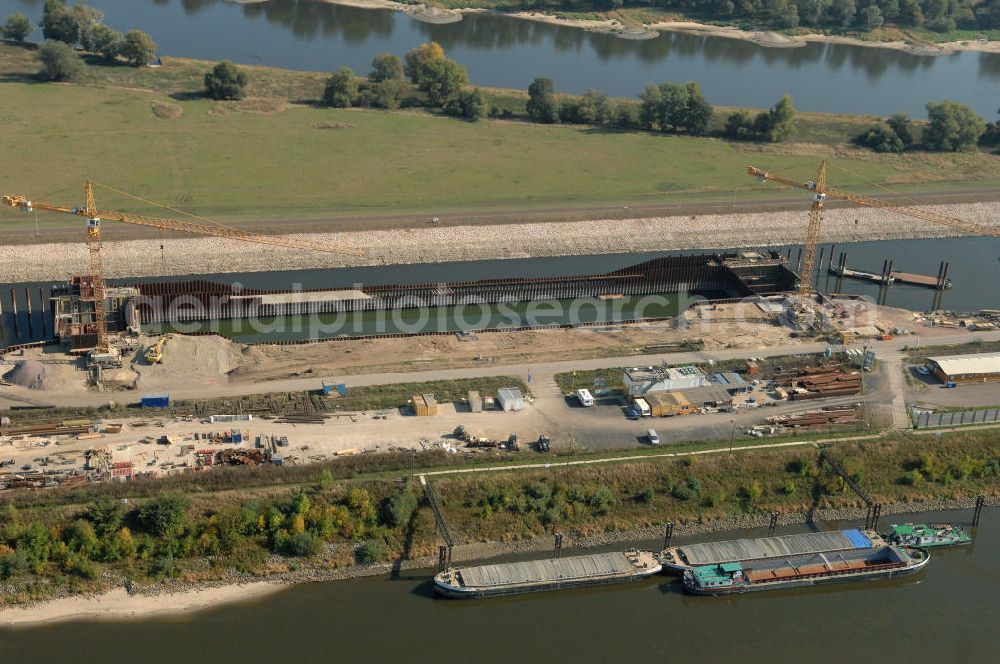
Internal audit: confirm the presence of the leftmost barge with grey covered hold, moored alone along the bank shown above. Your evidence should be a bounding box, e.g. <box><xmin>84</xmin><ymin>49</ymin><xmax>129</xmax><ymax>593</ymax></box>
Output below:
<box><xmin>434</xmin><ymin>549</ymin><xmax>662</xmax><ymax>599</ymax></box>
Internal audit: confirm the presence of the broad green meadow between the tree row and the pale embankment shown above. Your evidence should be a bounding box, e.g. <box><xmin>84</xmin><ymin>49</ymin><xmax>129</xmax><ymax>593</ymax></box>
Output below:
<box><xmin>0</xmin><ymin>45</ymin><xmax>1000</xmax><ymax>230</ymax></box>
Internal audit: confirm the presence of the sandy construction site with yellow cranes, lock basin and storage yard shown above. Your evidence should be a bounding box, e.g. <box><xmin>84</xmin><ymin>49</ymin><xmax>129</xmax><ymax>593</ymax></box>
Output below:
<box><xmin>0</xmin><ymin>166</ymin><xmax>998</xmax><ymax>488</ymax></box>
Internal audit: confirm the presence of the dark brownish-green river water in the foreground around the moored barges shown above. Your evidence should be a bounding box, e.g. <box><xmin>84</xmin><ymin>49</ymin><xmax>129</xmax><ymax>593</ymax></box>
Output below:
<box><xmin>0</xmin><ymin>508</ymin><xmax>1000</xmax><ymax>664</ymax></box>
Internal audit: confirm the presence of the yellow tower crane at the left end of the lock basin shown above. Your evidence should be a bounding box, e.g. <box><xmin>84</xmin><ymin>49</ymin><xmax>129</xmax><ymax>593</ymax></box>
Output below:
<box><xmin>3</xmin><ymin>180</ymin><xmax>364</xmax><ymax>354</ymax></box>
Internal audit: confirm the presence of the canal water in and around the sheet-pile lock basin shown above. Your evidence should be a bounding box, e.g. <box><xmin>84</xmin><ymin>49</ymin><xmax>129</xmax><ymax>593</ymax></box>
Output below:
<box><xmin>0</xmin><ymin>238</ymin><xmax>1000</xmax><ymax>345</ymax></box>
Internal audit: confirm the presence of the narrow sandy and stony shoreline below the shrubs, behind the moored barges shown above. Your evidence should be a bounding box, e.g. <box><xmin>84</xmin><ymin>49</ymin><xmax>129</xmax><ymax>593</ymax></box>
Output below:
<box><xmin>0</xmin><ymin>499</ymin><xmax>992</xmax><ymax>627</ymax></box>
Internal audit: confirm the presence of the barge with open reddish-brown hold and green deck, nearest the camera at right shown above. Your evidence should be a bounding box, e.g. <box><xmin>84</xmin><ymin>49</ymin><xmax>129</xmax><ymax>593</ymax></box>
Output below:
<box><xmin>684</xmin><ymin>545</ymin><xmax>930</xmax><ymax>595</ymax></box>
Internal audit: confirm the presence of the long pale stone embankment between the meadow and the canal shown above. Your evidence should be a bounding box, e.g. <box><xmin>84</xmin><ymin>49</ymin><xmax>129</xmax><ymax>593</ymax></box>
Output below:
<box><xmin>0</xmin><ymin>202</ymin><xmax>1000</xmax><ymax>283</ymax></box>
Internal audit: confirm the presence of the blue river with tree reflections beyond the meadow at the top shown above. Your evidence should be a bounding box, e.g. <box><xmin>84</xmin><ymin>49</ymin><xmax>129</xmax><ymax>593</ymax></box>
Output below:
<box><xmin>0</xmin><ymin>0</ymin><xmax>1000</xmax><ymax>119</ymax></box>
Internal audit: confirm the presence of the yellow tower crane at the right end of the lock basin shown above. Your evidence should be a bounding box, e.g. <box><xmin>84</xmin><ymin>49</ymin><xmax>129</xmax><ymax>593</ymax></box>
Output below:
<box><xmin>747</xmin><ymin>161</ymin><xmax>1000</xmax><ymax>297</ymax></box>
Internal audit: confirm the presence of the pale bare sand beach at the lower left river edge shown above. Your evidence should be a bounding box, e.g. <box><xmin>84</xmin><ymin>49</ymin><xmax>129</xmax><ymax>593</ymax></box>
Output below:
<box><xmin>0</xmin><ymin>581</ymin><xmax>284</xmax><ymax>627</ymax></box>
